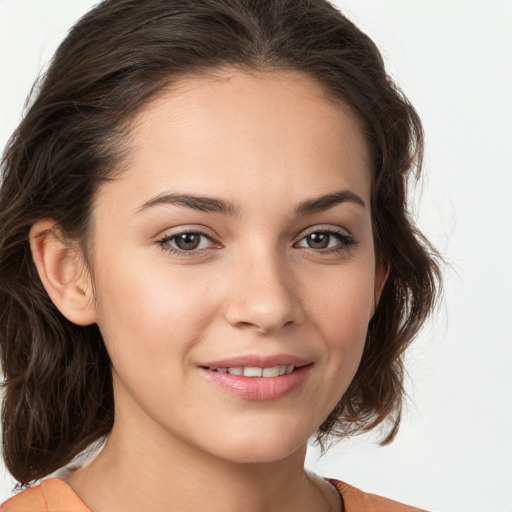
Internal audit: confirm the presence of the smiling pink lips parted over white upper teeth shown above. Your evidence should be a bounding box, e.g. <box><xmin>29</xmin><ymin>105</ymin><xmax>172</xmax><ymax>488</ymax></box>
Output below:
<box><xmin>200</xmin><ymin>356</ymin><xmax>312</xmax><ymax>402</ymax></box>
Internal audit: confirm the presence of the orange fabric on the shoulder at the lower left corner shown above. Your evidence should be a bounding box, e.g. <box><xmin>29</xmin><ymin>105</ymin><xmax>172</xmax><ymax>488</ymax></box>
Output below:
<box><xmin>0</xmin><ymin>478</ymin><xmax>90</xmax><ymax>512</ymax></box>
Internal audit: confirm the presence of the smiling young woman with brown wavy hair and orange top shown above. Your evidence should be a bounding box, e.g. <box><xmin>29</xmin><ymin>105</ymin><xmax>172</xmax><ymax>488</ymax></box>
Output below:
<box><xmin>0</xmin><ymin>0</ymin><xmax>440</xmax><ymax>512</ymax></box>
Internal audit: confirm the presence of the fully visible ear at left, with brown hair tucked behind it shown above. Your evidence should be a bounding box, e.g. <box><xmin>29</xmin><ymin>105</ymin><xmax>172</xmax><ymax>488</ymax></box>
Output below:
<box><xmin>30</xmin><ymin>219</ymin><xmax>96</xmax><ymax>325</ymax></box>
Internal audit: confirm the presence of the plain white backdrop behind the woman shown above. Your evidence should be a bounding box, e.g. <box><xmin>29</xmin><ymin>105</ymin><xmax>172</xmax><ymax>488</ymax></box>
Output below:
<box><xmin>0</xmin><ymin>0</ymin><xmax>512</xmax><ymax>512</ymax></box>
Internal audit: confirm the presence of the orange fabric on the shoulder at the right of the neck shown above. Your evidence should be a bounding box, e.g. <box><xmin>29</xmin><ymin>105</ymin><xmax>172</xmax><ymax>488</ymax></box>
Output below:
<box><xmin>328</xmin><ymin>479</ymin><xmax>426</xmax><ymax>512</ymax></box>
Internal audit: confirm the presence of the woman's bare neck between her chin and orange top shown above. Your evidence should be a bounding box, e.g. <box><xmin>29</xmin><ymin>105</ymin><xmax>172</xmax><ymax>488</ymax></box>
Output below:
<box><xmin>67</xmin><ymin>416</ymin><xmax>340</xmax><ymax>512</ymax></box>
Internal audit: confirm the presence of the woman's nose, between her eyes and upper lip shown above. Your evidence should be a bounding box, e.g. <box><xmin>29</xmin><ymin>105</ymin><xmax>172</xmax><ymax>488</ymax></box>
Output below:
<box><xmin>225</xmin><ymin>250</ymin><xmax>304</xmax><ymax>334</ymax></box>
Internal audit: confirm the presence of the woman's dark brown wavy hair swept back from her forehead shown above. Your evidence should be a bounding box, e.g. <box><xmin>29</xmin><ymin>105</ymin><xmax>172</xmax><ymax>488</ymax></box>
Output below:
<box><xmin>0</xmin><ymin>0</ymin><xmax>440</xmax><ymax>485</ymax></box>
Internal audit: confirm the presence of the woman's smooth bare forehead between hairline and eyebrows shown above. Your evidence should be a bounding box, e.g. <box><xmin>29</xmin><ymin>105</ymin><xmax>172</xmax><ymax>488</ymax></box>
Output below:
<box><xmin>96</xmin><ymin>68</ymin><xmax>370</xmax><ymax>212</ymax></box>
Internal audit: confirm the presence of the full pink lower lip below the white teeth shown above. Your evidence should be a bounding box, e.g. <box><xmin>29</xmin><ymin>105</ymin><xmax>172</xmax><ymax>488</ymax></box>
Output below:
<box><xmin>201</xmin><ymin>365</ymin><xmax>311</xmax><ymax>402</ymax></box>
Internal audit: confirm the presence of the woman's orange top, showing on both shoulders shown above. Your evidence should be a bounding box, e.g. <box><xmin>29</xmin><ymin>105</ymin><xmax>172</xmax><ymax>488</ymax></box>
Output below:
<box><xmin>0</xmin><ymin>478</ymin><xmax>425</xmax><ymax>512</ymax></box>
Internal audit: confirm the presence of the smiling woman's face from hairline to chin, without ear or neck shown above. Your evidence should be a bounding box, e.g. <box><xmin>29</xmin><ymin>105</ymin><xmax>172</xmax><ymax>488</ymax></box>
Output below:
<box><xmin>88</xmin><ymin>69</ymin><xmax>385</xmax><ymax>462</ymax></box>
